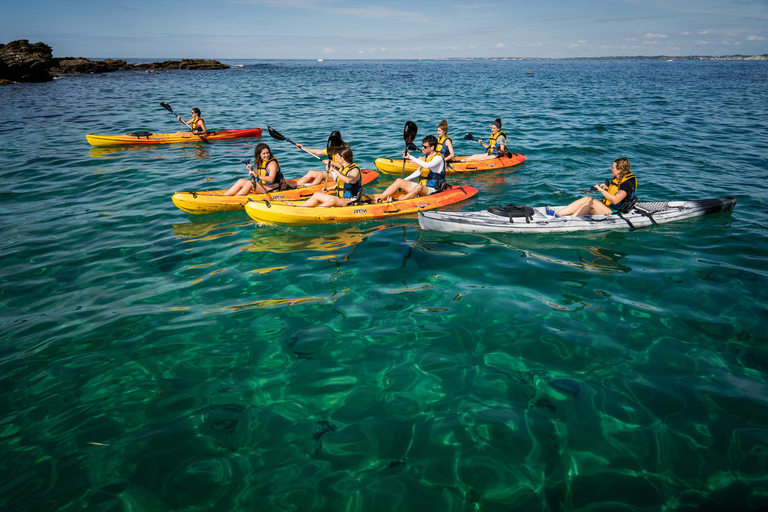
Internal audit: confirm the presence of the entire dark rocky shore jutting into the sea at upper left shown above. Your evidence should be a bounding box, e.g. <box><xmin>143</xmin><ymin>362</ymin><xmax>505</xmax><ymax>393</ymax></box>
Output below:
<box><xmin>0</xmin><ymin>39</ymin><xmax>229</xmax><ymax>85</ymax></box>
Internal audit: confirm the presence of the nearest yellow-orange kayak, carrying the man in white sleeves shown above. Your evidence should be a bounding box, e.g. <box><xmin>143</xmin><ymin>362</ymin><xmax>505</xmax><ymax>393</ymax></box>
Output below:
<box><xmin>245</xmin><ymin>185</ymin><xmax>477</xmax><ymax>225</ymax></box>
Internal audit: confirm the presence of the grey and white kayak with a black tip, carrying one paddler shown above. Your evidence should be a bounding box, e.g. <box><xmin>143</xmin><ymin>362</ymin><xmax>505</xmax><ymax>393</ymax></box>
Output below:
<box><xmin>419</xmin><ymin>196</ymin><xmax>736</xmax><ymax>233</ymax></box>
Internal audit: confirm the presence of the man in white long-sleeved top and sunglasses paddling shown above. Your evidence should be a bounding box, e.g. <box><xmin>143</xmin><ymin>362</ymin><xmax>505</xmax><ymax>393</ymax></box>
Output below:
<box><xmin>376</xmin><ymin>135</ymin><xmax>445</xmax><ymax>203</ymax></box>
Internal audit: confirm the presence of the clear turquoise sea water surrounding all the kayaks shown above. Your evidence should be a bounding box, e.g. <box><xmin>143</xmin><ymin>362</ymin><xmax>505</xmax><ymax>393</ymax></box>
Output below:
<box><xmin>0</xmin><ymin>61</ymin><xmax>768</xmax><ymax>512</ymax></box>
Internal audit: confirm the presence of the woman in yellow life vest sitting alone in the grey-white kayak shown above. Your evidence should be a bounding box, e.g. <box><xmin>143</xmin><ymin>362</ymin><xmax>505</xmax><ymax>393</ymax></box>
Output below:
<box><xmin>546</xmin><ymin>158</ymin><xmax>637</xmax><ymax>217</ymax></box>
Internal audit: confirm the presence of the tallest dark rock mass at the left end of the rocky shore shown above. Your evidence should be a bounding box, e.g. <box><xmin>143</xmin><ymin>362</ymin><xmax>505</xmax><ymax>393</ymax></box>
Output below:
<box><xmin>0</xmin><ymin>39</ymin><xmax>53</xmax><ymax>82</ymax></box>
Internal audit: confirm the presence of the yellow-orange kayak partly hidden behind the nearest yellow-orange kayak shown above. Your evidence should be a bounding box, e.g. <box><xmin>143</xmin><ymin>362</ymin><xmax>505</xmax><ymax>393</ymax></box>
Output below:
<box><xmin>171</xmin><ymin>169</ymin><xmax>379</xmax><ymax>215</ymax></box>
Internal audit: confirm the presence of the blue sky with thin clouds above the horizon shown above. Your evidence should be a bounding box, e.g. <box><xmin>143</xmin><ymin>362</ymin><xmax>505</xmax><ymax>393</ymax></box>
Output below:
<box><xmin>0</xmin><ymin>0</ymin><xmax>768</xmax><ymax>59</ymax></box>
